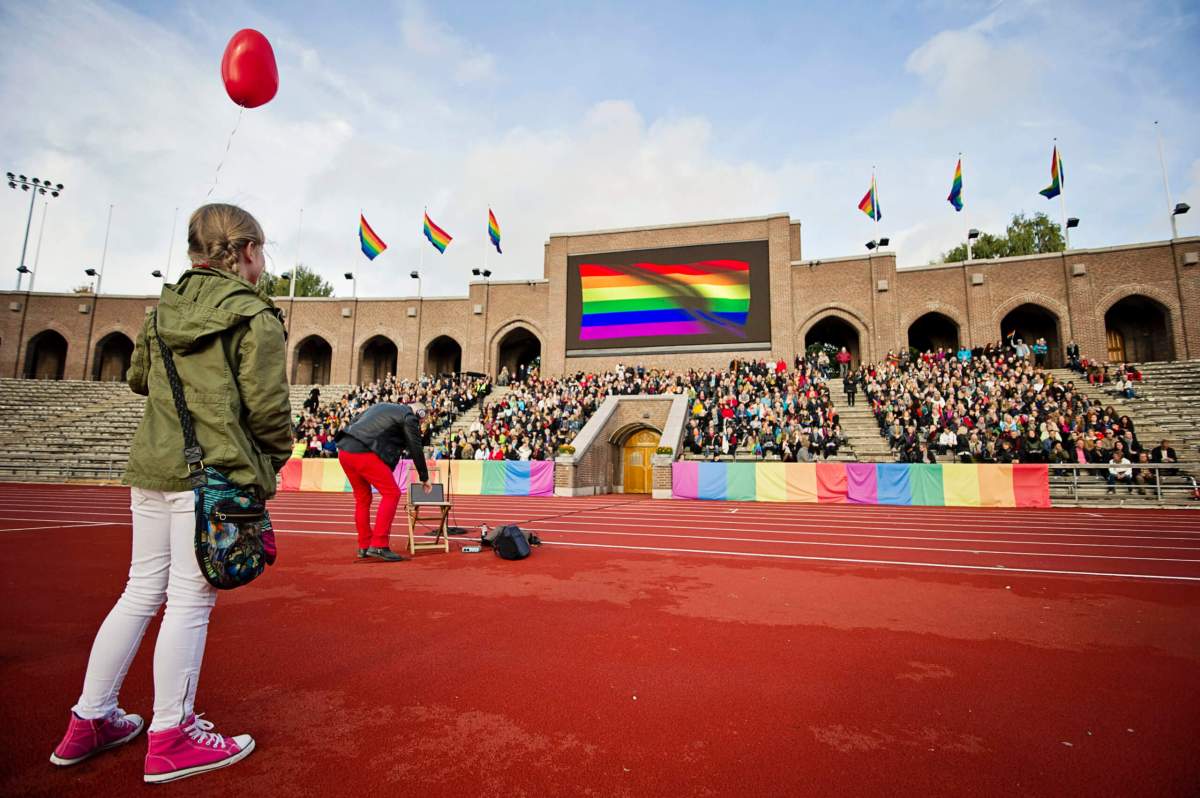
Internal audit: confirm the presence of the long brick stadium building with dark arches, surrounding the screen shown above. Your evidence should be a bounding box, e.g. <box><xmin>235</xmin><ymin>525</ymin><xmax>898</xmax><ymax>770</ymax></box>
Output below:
<box><xmin>0</xmin><ymin>215</ymin><xmax>1200</xmax><ymax>384</ymax></box>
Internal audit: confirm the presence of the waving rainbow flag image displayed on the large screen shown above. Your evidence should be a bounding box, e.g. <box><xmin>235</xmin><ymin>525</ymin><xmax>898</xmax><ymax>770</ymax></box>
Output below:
<box><xmin>580</xmin><ymin>260</ymin><xmax>750</xmax><ymax>341</ymax></box>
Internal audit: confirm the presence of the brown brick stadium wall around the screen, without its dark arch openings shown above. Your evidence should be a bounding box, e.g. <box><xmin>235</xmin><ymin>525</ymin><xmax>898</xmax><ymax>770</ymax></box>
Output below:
<box><xmin>0</xmin><ymin>215</ymin><xmax>1200</xmax><ymax>384</ymax></box>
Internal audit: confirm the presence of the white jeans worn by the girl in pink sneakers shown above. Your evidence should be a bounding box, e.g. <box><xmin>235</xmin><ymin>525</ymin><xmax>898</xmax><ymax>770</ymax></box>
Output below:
<box><xmin>74</xmin><ymin>487</ymin><xmax>217</xmax><ymax>732</ymax></box>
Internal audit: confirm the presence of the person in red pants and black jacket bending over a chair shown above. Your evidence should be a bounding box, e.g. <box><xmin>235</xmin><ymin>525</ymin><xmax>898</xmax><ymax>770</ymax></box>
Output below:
<box><xmin>334</xmin><ymin>402</ymin><xmax>430</xmax><ymax>563</ymax></box>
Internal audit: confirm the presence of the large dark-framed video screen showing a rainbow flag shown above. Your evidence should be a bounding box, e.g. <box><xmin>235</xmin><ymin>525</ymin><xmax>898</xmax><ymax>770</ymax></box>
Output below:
<box><xmin>566</xmin><ymin>241</ymin><xmax>770</xmax><ymax>355</ymax></box>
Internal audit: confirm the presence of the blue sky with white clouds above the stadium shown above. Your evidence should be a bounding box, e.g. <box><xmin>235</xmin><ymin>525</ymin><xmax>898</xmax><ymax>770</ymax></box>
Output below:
<box><xmin>0</xmin><ymin>0</ymin><xmax>1200</xmax><ymax>296</ymax></box>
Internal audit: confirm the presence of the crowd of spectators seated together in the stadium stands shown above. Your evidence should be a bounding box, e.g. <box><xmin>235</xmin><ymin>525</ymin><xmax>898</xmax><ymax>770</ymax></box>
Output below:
<box><xmin>296</xmin><ymin>337</ymin><xmax>1176</xmax><ymax>491</ymax></box>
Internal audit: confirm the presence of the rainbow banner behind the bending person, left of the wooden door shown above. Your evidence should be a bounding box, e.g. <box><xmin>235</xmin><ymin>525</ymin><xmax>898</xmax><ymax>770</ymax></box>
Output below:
<box><xmin>280</xmin><ymin>457</ymin><xmax>554</xmax><ymax>496</ymax></box>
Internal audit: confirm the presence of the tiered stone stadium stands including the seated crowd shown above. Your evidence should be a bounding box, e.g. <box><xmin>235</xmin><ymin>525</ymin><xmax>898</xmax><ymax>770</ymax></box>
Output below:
<box><xmin>0</xmin><ymin>354</ymin><xmax>1200</xmax><ymax>504</ymax></box>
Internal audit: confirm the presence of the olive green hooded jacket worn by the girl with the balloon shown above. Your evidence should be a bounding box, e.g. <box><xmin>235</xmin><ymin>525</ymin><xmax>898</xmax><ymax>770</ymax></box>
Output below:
<box><xmin>124</xmin><ymin>269</ymin><xmax>292</xmax><ymax>498</ymax></box>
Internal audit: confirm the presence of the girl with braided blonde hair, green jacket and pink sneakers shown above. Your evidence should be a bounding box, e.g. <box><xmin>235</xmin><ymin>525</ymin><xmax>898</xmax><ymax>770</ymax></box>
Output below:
<box><xmin>50</xmin><ymin>204</ymin><xmax>292</xmax><ymax>784</ymax></box>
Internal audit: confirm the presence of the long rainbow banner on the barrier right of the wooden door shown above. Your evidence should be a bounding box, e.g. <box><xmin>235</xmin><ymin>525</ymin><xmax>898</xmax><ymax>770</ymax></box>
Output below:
<box><xmin>671</xmin><ymin>460</ymin><xmax>1050</xmax><ymax>508</ymax></box>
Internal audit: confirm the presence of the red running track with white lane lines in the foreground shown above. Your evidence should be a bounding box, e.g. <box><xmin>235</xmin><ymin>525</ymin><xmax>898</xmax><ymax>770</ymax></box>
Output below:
<box><xmin>0</xmin><ymin>485</ymin><xmax>1200</xmax><ymax>798</ymax></box>
